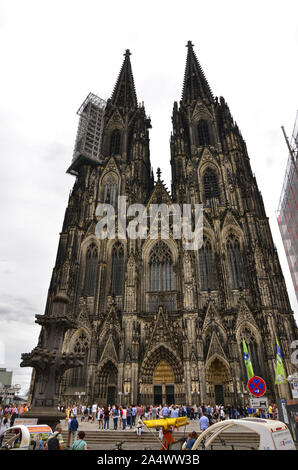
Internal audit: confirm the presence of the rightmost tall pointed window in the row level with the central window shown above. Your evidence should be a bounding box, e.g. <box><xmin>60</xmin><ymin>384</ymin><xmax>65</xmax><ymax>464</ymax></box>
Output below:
<box><xmin>227</xmin><ymin>234</ymin><xmax>245</xmax><ymax>289</ymax></box>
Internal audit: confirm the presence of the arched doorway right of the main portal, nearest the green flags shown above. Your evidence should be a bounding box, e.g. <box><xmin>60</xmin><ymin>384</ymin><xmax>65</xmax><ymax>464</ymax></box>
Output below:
<box><xmin>206</xmin><ymin>356</ymin><xmax>233</xmax><ymax>405</ymax></box>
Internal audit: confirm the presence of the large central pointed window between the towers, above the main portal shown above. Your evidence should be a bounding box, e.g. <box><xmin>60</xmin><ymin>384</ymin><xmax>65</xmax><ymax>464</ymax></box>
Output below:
<box><xmin>149</xmin><ymin>241</ymin><xmax>175</xmax><ymax>292</ymax></box>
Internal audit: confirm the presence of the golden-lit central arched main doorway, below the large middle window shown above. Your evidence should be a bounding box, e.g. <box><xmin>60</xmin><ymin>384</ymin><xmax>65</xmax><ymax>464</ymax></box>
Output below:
<box><xmin>153</xmin><ymin>360</ymin><xmax>175</xmax><ymax>405</ymax></box>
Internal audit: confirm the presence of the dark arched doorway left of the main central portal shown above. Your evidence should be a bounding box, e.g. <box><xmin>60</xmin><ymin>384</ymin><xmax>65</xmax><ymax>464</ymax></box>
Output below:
<box><xmin>95</xmin><ymin>361</ymin><xmax>119</xmax><ymax>406</ymax></box>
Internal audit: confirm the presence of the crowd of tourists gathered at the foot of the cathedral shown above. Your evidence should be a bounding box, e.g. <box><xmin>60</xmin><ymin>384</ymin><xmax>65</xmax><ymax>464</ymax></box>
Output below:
<box><xmin>0</xmin><ymin>403</ymin><xmax>278</xmax><ymax>450</ymax></box>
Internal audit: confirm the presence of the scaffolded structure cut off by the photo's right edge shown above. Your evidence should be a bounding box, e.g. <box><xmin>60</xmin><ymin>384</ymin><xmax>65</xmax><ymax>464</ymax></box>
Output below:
<box><xmin>277</xmin><ymin>112</ymin><xmax>298</xmax><ymax>300</ymax></box>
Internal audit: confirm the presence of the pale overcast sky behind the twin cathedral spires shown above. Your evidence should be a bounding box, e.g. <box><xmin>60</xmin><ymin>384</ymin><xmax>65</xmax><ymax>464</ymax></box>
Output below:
<box><xmin>0</xmin><ymin>0</ymin><xmax>298</xmax><ymax>392</ymax></box>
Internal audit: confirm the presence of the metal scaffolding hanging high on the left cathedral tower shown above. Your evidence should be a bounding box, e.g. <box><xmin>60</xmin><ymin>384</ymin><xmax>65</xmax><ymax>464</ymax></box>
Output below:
<box><xmin>67</xmin><ymin>93</ymin><xmax>106</xmax><ymax>175</ymax></box>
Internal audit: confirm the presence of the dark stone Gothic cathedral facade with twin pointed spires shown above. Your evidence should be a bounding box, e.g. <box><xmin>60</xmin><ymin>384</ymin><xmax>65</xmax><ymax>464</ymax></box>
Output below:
<box><xmin>25</xmin><ymin>42</ymin><xmax>297</xmax><ymax>404</ymax></box>
